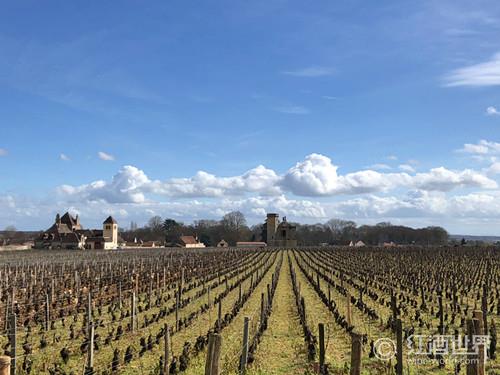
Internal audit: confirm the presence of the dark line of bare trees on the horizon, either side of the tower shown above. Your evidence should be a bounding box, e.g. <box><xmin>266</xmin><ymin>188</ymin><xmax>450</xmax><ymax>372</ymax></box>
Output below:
<box><xmin>121</xmin><ymin>211</ymin><xmax>448</xmax><ymax>246</ymax></box>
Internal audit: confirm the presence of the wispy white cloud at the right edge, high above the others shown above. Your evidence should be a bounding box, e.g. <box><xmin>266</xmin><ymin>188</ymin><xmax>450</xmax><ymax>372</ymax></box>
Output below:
<box><xmin>445</xmin><ymin>53</ymin><xmax>500</xmax><ymax>86</ymax></box>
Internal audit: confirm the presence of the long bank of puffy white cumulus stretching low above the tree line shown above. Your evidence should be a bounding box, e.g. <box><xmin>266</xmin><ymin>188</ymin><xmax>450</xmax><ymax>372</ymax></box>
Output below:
<box><xmin>58</xmin><ymin>154</ymin><xmax>497</xmax><ymax>203</ymax></box>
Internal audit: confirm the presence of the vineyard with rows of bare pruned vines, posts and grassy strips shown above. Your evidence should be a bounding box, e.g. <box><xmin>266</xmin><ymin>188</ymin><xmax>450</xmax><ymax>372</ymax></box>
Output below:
<box><xmin>0</xmin><ymin>247</ymin><xmax>500</xmax><ymax>375</ymax></box>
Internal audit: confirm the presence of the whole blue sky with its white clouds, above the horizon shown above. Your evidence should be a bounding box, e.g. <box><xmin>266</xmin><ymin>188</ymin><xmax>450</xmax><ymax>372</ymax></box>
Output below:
<box><xmin>0</xmin><ymin>0</ymin><xmax>500</xmax><ymax>234</ymax></box>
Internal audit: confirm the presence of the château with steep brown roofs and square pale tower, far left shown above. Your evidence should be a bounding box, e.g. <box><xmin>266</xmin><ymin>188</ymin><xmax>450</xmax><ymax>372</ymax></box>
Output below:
<box><xmin>34</xmin><ymin>212</ymin><xmax>119</xmax><ymax>250</ymax></box>
